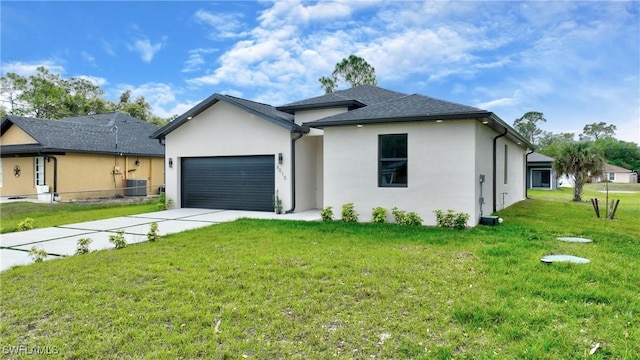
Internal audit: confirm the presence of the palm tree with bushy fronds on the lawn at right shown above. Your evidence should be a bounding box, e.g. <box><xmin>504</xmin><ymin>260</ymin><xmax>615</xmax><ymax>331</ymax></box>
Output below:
<box><xmin>553</xmin><ymin>141</ymin><xmax>604</xmax><ymax>201</ymax></box>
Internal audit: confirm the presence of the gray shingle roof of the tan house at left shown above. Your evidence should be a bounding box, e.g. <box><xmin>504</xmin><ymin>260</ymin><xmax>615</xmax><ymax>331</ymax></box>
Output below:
<box><xmin>0</xmin><ymin>112</ymin><xmax>164</xmax><ymax>157</ymax></box>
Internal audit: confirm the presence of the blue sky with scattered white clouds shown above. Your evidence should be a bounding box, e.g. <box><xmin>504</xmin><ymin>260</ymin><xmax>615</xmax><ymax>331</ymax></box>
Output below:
<box><xmin>0</xmin><ymin>0</ymin><xmax>640</xmax><ymax>143</ymax></box>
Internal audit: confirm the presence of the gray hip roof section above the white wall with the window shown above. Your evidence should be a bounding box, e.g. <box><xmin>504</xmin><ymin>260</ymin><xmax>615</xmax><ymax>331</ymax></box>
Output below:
<box><xmin>305</xmin><ymin>94</ymin><xmax>491</xmax><ymax>128</ymax></box>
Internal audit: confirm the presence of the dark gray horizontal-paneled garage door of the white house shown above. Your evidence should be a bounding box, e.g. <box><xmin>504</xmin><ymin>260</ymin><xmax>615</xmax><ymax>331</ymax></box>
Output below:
<box><xmin>181</xmin><ymin>155</ymin><xmax>275</xmax><ymax>211</ymax></box>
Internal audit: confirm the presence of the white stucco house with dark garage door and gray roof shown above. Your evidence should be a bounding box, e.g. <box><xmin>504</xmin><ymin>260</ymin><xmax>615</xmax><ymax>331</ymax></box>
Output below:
<box><xmin>153</xmin><ymin>85</ymin><xmax>533</xmax><ymax>226</ymax></box>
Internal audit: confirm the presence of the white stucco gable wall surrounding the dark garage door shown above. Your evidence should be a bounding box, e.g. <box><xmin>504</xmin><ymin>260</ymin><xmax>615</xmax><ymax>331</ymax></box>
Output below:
<box><xmin>165</xmin><ymin>102</ymin><xmax>292</xmax><ymax>209</ymax></box>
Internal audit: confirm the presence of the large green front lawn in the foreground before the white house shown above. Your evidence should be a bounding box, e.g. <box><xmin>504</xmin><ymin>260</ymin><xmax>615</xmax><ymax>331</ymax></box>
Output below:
<box><xmin>0</xmin><ymin>191</ymin><xmax>640</xmax><ymax>359</ymax></box>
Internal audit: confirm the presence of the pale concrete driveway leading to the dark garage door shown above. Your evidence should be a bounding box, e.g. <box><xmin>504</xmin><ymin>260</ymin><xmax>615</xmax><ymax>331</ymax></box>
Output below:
<box><xmin>0</xmin><ymin>209</ymin><xmax>320</xmax><ymax>271</ymax></box>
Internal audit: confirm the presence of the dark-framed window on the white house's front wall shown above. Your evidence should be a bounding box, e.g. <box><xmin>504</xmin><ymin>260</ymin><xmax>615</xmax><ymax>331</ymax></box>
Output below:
<box><xmin>378</xmin><ymin>134</ymin><xmax>407</xmax><ymax>187</ymax></box>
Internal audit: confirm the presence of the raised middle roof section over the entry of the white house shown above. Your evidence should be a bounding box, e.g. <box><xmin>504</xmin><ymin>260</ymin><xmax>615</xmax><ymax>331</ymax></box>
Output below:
<box><xmin>277</xmin><ymin>85</ymin><xmax>407</xmax><ymax>113</ymax></box>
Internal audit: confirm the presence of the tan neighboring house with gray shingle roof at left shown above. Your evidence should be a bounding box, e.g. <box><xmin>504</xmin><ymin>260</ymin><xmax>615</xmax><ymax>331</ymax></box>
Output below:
<box><xmin>0</xmin><ymin>112</ymin><xmax>164</xmax><ymax>201</ymax></box>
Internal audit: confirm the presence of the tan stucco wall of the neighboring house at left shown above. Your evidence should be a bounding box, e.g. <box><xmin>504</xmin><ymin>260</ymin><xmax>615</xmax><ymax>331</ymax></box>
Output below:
<box><xmin>1</xmin><ymin>153</ymin><xmax>164</xmax><ymax>201</ymax></box>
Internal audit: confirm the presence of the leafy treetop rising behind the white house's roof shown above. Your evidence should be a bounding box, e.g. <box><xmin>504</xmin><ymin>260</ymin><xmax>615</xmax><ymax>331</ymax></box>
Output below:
<box><xmin>318</xmin><ymin>55</ymin><xmax>377</xmax><ymax>94</ymax></box>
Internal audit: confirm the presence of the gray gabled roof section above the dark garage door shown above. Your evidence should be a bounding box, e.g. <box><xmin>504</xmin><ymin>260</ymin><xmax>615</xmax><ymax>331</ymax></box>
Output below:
<box><xmin>151</xmin><ymin>94</ymin><xmax>308</xmax><ymax>139</ymax></box>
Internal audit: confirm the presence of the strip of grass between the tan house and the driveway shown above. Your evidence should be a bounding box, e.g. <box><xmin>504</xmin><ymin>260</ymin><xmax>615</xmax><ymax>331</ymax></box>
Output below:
<box><xmin>0</xmin><ymin>201</ymin><xmax>158</xmax><ymax>234</ymax></box>
